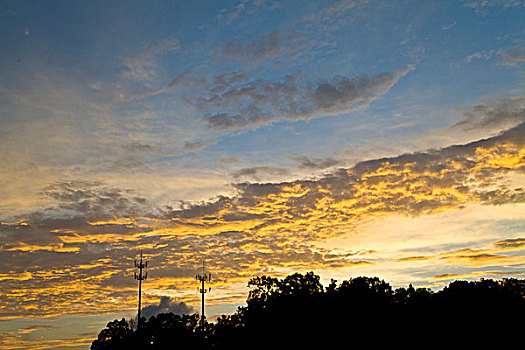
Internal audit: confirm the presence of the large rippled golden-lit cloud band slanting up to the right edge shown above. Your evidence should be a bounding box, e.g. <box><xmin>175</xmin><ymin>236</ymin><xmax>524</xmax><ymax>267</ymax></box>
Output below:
<box><xmin>173</xmin><ymin>123</ymin><xmax>525</xmax><ymax>228</ymax></box>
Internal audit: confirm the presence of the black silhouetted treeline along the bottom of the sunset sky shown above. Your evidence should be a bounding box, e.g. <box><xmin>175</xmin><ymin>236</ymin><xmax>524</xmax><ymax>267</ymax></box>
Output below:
<box><xmin>91</xmin><ymin>272</ymin><xmax>525</xmax><ymax>350</ymax></box>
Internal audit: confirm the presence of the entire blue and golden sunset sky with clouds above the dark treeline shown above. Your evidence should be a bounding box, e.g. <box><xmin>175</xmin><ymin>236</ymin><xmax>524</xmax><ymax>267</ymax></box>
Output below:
<box><xmin>0</xmin><ymin>0</ymin><xmax>525</xmax><ymax>350</ymax></box>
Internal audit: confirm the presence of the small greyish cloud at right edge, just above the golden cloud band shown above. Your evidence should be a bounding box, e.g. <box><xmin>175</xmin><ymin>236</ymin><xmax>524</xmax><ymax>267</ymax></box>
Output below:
<box><xmin>452</xmin><ymin>95</ymin><xmax>525</xmax><ymax>131</ymax></box>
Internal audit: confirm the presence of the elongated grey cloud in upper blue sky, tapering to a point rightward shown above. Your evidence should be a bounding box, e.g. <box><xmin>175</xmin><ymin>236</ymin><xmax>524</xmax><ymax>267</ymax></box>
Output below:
<box><xmin>191</xmin><ymin>65</ymin><xmax>414</xmax><ymax>131</ymax></box>
